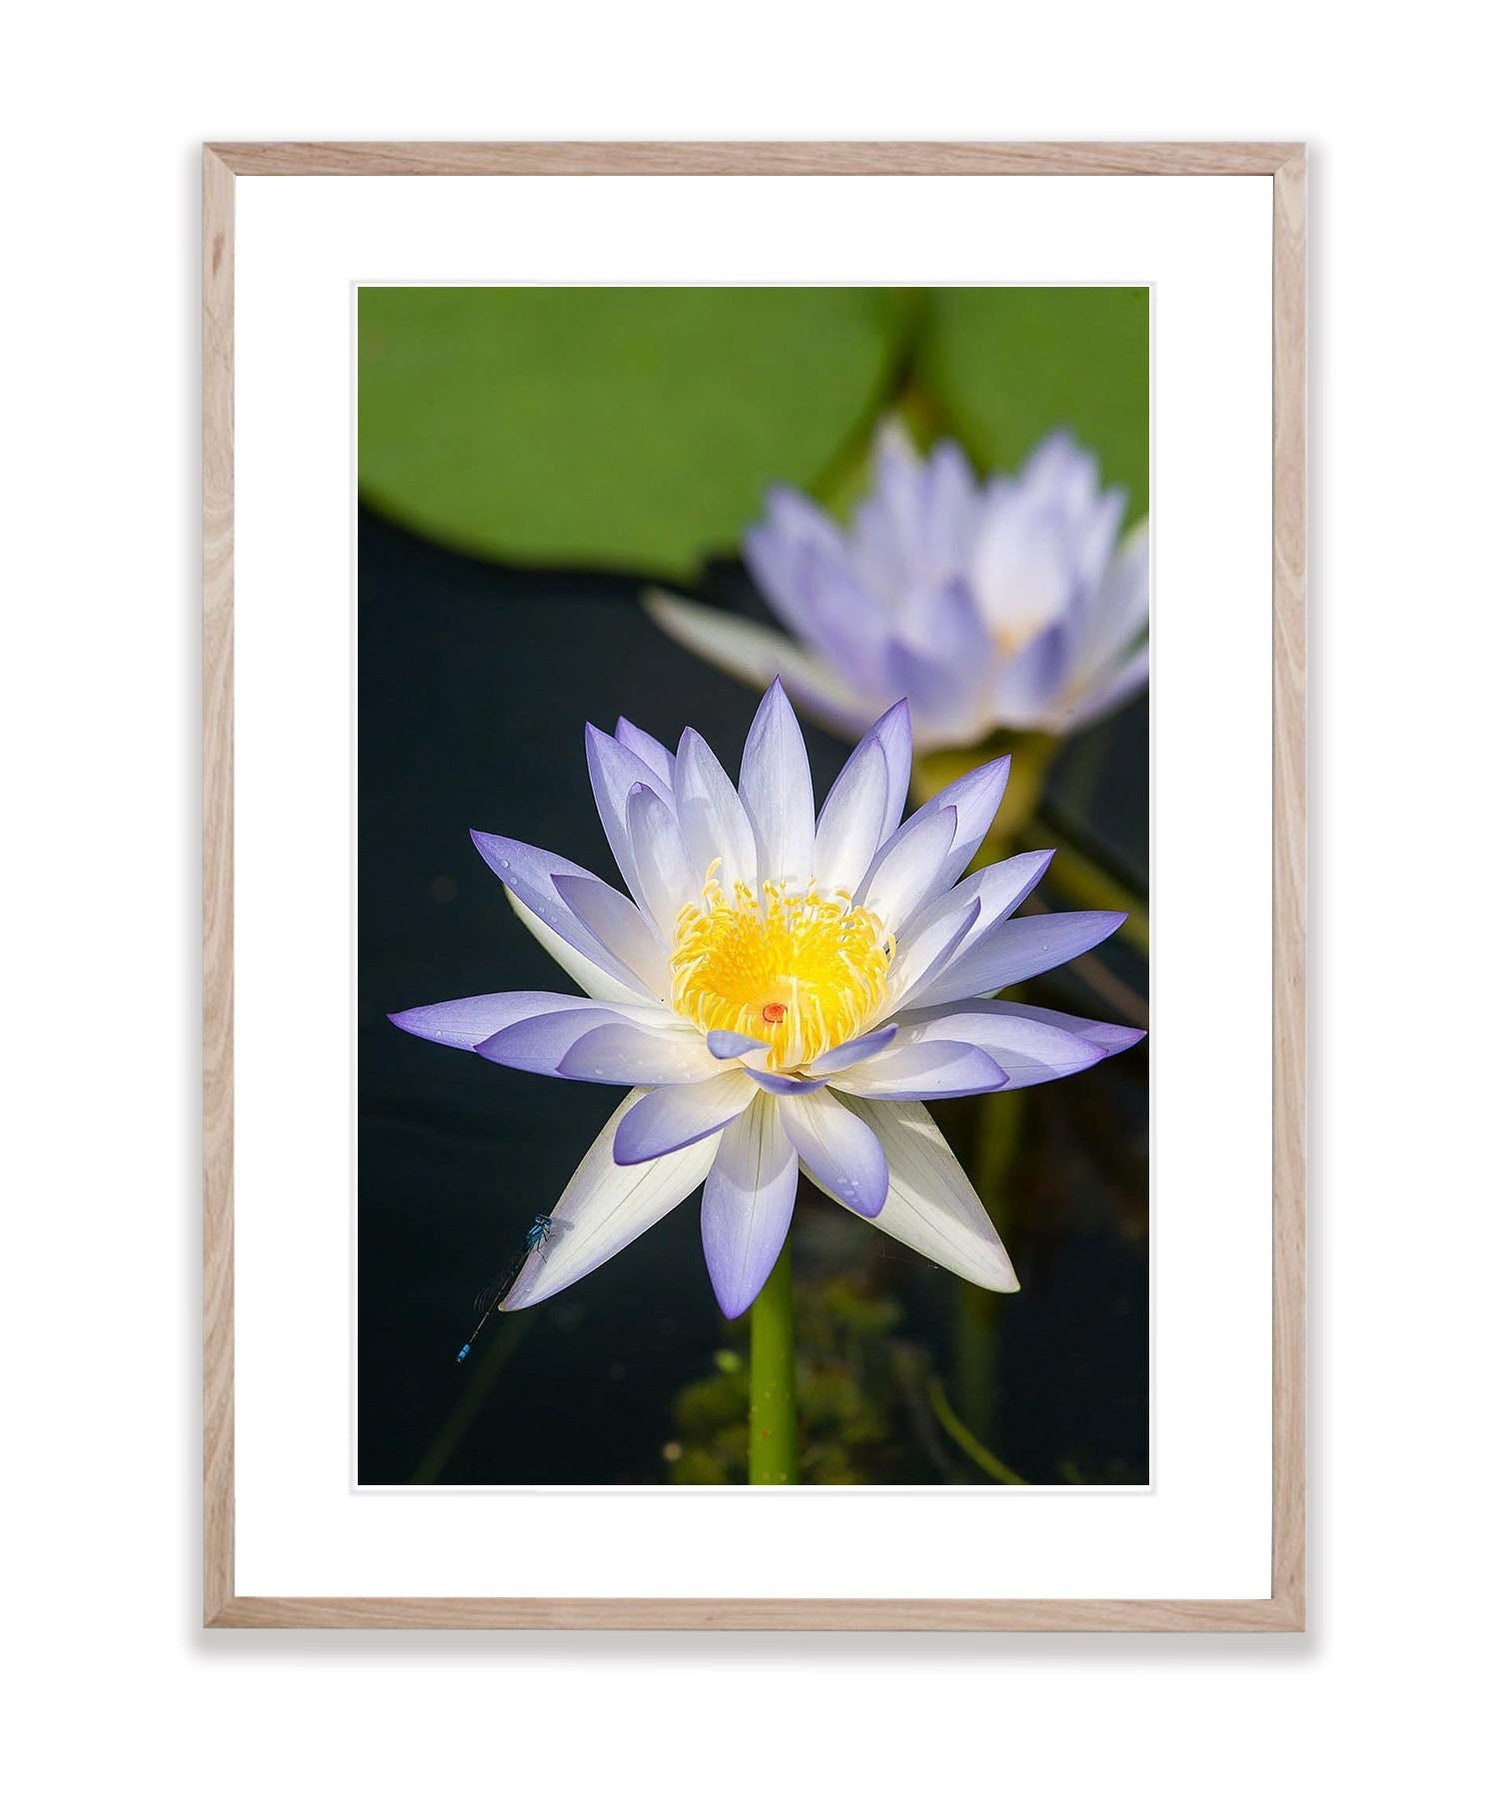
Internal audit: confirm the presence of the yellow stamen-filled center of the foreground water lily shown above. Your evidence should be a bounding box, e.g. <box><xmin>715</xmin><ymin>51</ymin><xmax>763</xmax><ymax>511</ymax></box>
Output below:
<box><xmin>671</xmin><ymin>864</ymin><xmax>894</xmax><ymax>1069</ymax></box>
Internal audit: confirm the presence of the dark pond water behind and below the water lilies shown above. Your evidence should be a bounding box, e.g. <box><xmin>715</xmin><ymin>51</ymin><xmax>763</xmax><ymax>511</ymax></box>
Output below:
<box><xmin>358</xmin><ymin>515</ymin><xmax>1148</xmax><ymax>1484</ymax></box>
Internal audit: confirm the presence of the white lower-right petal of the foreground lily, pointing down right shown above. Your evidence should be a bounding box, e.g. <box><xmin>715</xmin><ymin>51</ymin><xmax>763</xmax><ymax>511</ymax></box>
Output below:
<box><xmin>813</xmin><ymin>1097</ymin><xmax>1020</xmax><ymax>1293</ymax></box>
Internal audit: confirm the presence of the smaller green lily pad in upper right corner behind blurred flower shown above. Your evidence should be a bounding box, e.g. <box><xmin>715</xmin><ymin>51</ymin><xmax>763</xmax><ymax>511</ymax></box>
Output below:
<box><xmin>918</xmin><ymin>288</ymin><xmax>1150</xmax><ymax>520</ymax></box>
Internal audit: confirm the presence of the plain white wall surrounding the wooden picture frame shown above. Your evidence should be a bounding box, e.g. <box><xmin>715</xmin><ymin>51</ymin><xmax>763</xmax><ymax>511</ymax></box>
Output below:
<box><xmin>0</xmin><ymin>0</ymin><xmax>1499</xmax><ymax>1795</ymax></box>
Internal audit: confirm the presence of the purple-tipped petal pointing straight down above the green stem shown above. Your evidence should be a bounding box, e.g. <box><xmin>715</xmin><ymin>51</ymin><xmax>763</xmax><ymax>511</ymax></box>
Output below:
<box><xmin>702</xmin><ymin>1096</ymin><xmax>797</xmax><ymax>1319</ymax></box>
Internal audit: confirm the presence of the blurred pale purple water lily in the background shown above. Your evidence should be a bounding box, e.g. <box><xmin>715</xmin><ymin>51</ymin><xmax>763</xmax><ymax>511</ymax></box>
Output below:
<box><xmin>646</xmin><ymin>426</ymin><xmax>1150</xmax><ymax>750</ymax></box>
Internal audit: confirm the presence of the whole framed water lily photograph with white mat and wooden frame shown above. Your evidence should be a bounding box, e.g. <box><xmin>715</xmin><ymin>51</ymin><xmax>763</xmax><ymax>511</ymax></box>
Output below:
<box><xmin>203</xmin><ymin>144</ymin><xmax>1306</xmax><ymax>1632</ymax></box>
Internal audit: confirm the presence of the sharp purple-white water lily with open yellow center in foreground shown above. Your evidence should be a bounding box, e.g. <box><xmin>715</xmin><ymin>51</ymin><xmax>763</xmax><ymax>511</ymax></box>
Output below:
<box><xmin>392</xmin><ymin>682</ymin><xmax>1141</xmax><ymax>1317</ymax></box>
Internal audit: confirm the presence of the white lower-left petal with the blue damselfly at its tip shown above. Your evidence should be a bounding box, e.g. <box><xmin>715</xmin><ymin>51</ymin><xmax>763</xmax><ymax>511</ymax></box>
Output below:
<box><xmin>502</xmin><ymin>1088</ymin><xmax>718</xmax><ymax>1311</ymax></box>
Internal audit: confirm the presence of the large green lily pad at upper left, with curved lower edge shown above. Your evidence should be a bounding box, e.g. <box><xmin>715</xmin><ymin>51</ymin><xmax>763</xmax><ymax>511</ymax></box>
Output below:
<box><xmin>360</xmin><ymin>288</ymin><xmax>912</xmax><ymax>576</ymax></box>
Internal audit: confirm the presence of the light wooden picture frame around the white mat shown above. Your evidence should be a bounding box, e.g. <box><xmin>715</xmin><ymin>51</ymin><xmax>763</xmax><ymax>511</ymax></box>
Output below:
<box><xmin>203</xmin><ymin>142</ymin><xmax>1306</xmax><ymax>1632</ymax></box>
